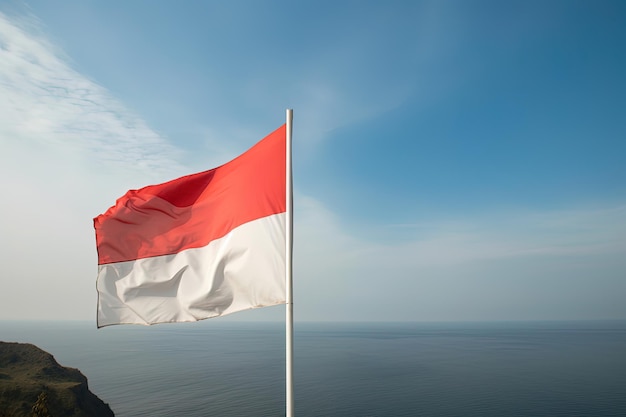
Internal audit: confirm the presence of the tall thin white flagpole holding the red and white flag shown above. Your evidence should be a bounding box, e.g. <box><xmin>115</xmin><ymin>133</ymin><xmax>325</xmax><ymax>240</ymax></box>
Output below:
<box><xmin>285</xmin><ymin>109</ymin><xmax>294</xmax><ymax>417</ymax></box>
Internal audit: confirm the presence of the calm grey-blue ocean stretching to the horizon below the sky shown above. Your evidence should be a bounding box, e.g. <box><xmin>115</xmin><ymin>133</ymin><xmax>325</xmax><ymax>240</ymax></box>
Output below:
<box><xmin>0</xmin><ymin>319</ymin><xmax>626</xmax><ymax>417</ymax></box>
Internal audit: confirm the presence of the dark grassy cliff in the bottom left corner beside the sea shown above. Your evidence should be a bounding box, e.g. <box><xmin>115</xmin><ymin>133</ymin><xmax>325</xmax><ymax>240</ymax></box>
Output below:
<box><xmin>0</xmin><ymin>342</ymin><xmax>114</xmax><ymax>417</ymax></box>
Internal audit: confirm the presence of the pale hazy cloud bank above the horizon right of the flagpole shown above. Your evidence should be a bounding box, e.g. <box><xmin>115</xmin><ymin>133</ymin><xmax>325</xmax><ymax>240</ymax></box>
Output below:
<box><xmin>294</xmin><ymin>196</ymin><xmax>626</xmax><ymax>321</ymax></box>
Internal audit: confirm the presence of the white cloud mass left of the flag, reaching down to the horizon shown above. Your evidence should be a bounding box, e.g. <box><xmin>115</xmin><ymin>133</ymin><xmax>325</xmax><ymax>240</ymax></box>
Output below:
<box><xmin>0</xmin><ymin>13</ymin><xmax>184</xmax><ymax>319</ymax></box>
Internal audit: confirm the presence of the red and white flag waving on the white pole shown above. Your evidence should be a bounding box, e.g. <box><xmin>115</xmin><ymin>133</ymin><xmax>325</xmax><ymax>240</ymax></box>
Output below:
<box><xmin>94</xmin><ymin>125</ymin><xmax>287</xmax><ymax>327</ymax></box>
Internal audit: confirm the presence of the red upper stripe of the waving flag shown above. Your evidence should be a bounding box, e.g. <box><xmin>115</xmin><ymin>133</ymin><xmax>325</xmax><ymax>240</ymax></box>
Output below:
<box><xmin>94</xmin><ymin>125</ymin><xmax>286</xmax><ymax>265</ymax></box>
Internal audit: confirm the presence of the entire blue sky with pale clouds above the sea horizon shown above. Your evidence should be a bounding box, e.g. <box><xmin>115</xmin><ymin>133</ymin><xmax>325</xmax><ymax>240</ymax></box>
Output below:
<box><xmin>0</xmin><ymin>0</ymin><xmax>626</xmax><ymax>325</ymax></box>
